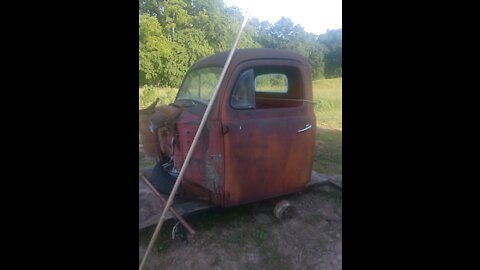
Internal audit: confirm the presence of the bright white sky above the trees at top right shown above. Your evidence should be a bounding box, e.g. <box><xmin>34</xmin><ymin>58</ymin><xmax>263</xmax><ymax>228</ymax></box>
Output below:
<box><xmin>223</xmin><ymin>0</ymin><xmax>342</xmax><ymax>35</ymax></box>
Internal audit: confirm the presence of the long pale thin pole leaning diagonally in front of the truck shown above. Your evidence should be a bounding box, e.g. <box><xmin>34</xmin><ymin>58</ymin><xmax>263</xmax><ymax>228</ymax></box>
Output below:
<box><xmin>139</xmin><ymin>10</ymin><xmax>250</xmax><ymax>270</ymax></box>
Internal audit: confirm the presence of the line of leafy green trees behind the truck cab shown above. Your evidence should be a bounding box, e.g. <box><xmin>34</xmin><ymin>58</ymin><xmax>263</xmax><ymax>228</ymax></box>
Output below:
<box><xmin>139</xmin><ymin>0</ymin><xmax>342</xmax><ymax>87</ymax></box>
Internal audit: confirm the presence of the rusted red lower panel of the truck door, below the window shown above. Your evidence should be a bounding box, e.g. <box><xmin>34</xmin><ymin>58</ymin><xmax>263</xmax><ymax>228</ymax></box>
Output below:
<box><xmin>225</xmin><ymin>112</ymin><xmax>315</xmax><ymax>206</ymax></box>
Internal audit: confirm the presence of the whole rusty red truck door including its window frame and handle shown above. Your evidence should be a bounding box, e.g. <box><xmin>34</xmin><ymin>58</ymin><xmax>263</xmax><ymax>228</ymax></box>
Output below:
<box><xmin>221</xmin><ymin>59</ymin><xmax>316</xmax><ymax>206</ymax></box>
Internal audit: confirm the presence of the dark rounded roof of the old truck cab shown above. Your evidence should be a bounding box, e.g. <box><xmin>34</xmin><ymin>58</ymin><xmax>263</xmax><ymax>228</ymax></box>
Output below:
<box><xmin>190</xmin><ymin>48</ymin><xmax>308</xmax><ymax>70</ymax></box>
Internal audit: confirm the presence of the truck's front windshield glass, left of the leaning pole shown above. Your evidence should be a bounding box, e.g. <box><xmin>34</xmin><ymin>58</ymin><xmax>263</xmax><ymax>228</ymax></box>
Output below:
<box><xmin>176</xmin><ymin>67</ymin><xmax>222</xmax><ymax>104</ymax></box>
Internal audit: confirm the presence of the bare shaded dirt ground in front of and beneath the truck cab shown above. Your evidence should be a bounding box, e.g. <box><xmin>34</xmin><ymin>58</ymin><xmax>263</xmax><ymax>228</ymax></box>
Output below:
<box><xmin>139</xmin><ymin>182</ymin><xmax>342</xmax><ymax>270</ymax></box>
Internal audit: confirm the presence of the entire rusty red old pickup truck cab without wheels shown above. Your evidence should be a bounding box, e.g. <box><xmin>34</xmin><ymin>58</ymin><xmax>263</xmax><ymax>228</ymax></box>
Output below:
<box><xmin>148</xmin><ymin>49</ymin><xmax>316</xmax><ymax>206</ymax></box>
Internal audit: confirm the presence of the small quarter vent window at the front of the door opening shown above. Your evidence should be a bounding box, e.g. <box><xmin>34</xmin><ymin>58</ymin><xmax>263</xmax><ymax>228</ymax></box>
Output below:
<box><xmin>230</xmin><ymin>69</ymin><xmax>255</xmax><ymax>109</ymax></box>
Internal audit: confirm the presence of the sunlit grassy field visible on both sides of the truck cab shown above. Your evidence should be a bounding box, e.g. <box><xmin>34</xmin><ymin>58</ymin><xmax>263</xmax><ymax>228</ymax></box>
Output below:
<box><xmin>139</xmin><ymin>78</ymin><xmax>342</xmax><ymax>174</ymax></box>
